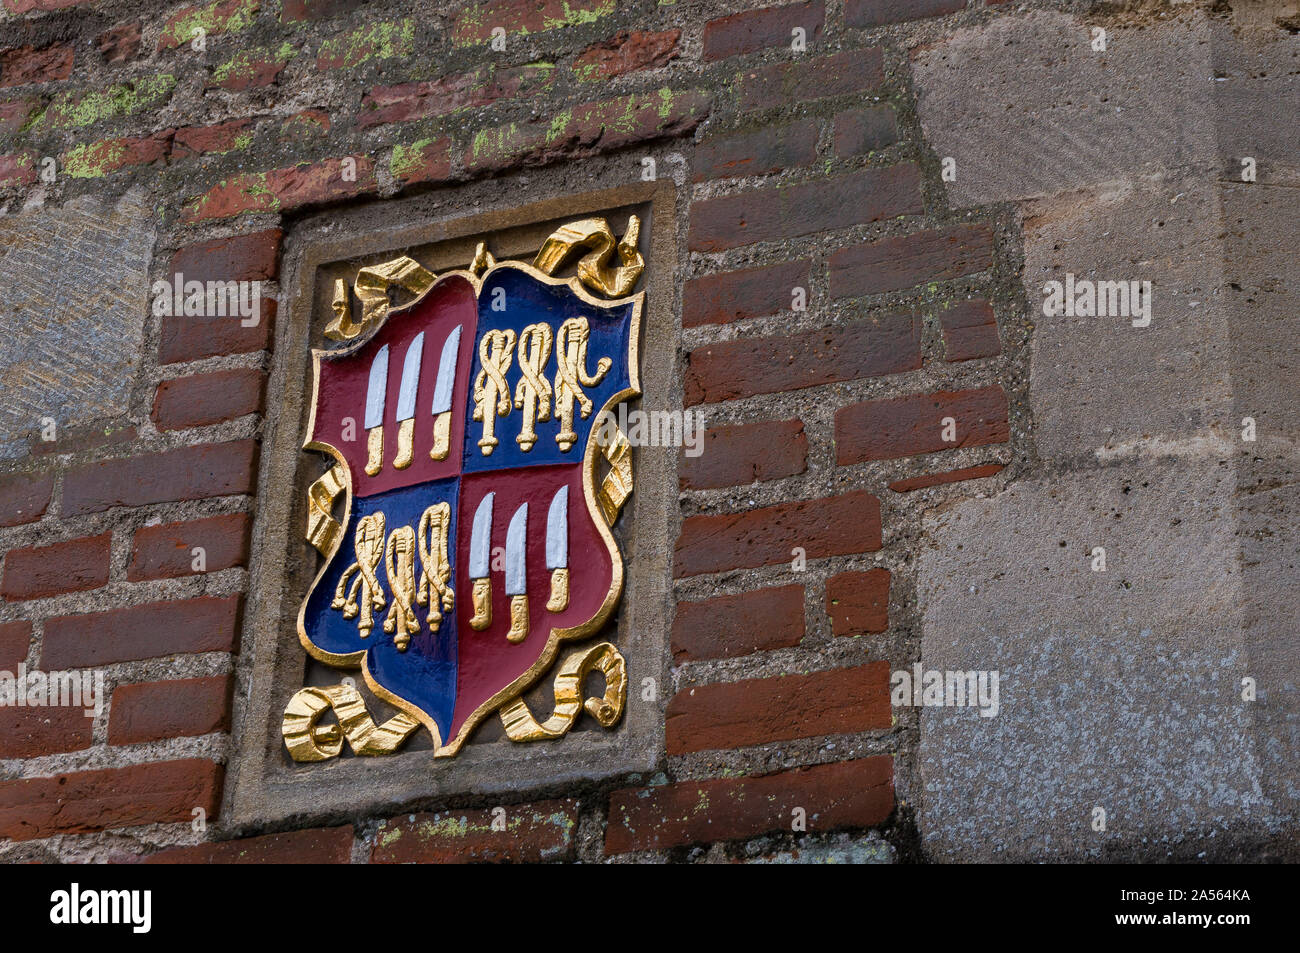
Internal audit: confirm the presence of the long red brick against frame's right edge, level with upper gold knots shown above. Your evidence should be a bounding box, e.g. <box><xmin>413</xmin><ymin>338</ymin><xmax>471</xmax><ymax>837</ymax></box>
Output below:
<box><xmin>685</xmin><ymin>315</ymin><xmax>920</xmax><ymax>407</ymax></box>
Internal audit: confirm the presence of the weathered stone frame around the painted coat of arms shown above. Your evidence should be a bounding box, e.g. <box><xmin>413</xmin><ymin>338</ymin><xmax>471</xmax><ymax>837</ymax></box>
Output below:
<box><xmin>224</xmin><ymin>178</ymin><xmax>681</xmax><ymax>829</ymax></box>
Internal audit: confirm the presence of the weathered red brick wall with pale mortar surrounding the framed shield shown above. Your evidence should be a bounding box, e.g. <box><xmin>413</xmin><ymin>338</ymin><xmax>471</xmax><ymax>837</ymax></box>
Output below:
<box><xmin>0</xmin><ymin>0</ymin><xmax>1028</xmax><ymax>862</ymax></box>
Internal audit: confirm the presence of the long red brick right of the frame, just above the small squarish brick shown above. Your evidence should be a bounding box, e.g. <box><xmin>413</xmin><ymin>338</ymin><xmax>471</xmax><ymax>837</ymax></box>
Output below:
<box><xmin>673</xmin><ymin>490</ymin><xmax>880</xmax><ymax>579</ymax></box>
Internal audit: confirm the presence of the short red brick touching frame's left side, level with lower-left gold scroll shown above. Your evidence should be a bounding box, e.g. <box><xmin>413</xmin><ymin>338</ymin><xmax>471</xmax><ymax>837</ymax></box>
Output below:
<box><xmin>108</xmin><ymin>675</ymin><xmax>233</xmax><ymax>745</ymax></box>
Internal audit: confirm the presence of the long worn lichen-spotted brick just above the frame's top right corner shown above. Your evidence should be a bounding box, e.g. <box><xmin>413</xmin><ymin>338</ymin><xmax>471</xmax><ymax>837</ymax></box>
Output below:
<box><xmin>464</xmin><ymin>90</ymin><xmax>710</xmax><ymax>172</ymax></box>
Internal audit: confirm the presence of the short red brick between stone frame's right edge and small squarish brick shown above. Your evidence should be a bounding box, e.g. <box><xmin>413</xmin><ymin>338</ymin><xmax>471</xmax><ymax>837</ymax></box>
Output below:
<box><xmin>672</xmin><ymin>585</ymin><xmax>803</xmax><ymax>664</ymax></box>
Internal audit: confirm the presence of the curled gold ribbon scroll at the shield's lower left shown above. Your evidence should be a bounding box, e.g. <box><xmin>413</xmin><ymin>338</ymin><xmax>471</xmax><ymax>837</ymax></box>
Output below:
<box><xmin>280</xmin><ymin>685</ymin><xmax>420</xmax><ymax>762</ymax></box>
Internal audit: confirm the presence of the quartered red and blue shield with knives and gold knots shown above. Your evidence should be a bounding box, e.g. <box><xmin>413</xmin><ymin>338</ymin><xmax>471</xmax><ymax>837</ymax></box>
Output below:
<box><xmin>298</xmin><ymin>259</ymin><xmax>644</xmax><ymax>757</ymax></box>
